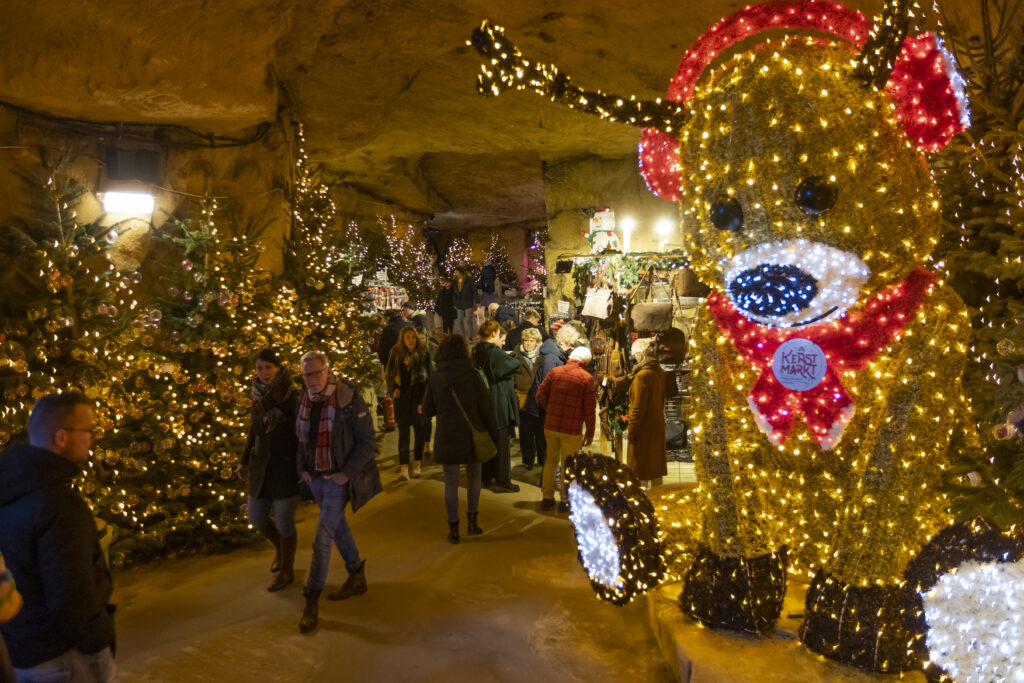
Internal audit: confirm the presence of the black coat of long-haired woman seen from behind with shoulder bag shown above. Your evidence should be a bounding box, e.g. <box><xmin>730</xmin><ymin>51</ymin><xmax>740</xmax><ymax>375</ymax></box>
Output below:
<box><xmin>423</xmin><ymin>359</ymin><xmax>498</xmax><ymax>465</ymax></box>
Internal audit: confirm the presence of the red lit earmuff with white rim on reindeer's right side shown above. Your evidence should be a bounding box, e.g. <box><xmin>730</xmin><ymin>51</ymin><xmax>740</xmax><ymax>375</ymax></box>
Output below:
<box><xmin>887</xmin><ymin>32</ymin><xmax>971</xmax><ymax>152</ymax></box>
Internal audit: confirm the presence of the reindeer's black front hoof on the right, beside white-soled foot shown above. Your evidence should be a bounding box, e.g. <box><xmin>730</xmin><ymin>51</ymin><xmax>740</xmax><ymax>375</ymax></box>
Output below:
<box><xmin>800</xmin><ymin>569</ymin><xmax>913</xmax><ymax>673</ymax></box>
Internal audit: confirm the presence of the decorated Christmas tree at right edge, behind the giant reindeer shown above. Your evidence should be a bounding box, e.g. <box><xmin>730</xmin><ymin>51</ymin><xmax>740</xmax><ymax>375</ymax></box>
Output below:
<box><xmin>936</xmin><ymin>2</ymin><xmax>1024</xmax><ymax>526</ymax></box>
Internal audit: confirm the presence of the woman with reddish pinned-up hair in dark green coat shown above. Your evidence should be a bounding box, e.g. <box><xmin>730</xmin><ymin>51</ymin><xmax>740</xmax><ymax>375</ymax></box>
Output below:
<box><xmin>473</xmin><ymin>321</ymin><xmax>519</xmax><ymax>494</ymax></box>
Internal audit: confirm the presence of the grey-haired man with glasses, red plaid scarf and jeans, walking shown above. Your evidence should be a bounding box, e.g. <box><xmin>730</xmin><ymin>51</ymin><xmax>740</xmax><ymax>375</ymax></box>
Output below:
<box><xmin>295</xmin><ymin>351</ymin><xmax>382</xmax><ymax>634</ymax></box>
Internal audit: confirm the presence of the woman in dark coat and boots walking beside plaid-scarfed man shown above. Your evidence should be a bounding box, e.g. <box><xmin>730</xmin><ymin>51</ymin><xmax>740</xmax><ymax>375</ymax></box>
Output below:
<box><xmin>238</xmin><ymin>348</ymin><xmax>299</xmax><ymax>591</ymax></box>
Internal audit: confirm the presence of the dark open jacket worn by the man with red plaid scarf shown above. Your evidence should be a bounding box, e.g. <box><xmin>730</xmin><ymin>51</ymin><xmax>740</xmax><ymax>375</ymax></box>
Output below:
<box><xmin>296</xmin><ymin>381</ymin><xmax>383</xmax><ymax>512</ymax></box>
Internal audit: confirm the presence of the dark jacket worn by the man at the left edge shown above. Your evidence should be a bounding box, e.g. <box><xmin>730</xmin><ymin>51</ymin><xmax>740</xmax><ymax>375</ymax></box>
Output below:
<box><xmin>0</xmin><ymin>445</ymin><xmax>115</xmax><ymax>669</ymax></box>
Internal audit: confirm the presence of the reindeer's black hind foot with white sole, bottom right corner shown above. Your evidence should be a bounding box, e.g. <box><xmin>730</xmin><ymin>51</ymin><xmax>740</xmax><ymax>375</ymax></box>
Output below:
<box><xmin>904</xmin><ymin>517</ymin><xmax>1024</xmax><ymax>681</ymax></box>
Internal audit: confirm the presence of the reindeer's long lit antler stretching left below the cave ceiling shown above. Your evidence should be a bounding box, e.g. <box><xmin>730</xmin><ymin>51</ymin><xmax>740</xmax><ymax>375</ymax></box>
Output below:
<box><xmin>469</xmin><ymin>20</ymin><xmax>687</xmax><ymax>133</ymax></box>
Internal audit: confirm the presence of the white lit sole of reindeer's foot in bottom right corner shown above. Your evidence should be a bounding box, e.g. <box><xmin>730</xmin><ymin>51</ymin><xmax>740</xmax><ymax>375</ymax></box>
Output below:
<box><xmin>923</xmin><ymin>561</ymin><xmax>1024</xmax><ymax>683</ymax></box>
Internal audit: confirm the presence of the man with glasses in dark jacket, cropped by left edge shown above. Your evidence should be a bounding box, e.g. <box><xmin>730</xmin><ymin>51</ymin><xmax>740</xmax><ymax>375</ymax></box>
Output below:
<box><xmin>0</xmin><ymin>392</ymin><xmax>117</xmax><ymax>681</ymax></box>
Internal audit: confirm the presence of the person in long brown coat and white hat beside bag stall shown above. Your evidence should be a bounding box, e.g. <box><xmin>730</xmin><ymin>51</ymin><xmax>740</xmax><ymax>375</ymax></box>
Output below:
<box><xmin>626</xmin><ymin>339</ymin><xmax>669</xmax><ymax>487</ymax></box>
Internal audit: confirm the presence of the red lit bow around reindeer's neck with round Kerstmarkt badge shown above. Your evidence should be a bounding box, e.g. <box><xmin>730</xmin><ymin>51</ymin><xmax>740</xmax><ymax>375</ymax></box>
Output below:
<box><xmin>708</xmin><ymin>267</ymin><xmax>935</xmax><ymax>451</ymax></box>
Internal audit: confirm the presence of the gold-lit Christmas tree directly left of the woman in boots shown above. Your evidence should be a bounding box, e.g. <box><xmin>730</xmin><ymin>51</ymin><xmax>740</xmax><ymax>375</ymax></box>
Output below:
<box><xmin>90</xmin><ymin>201</ymin><xmax>269</xmax><ymax>565</ymax></box>
